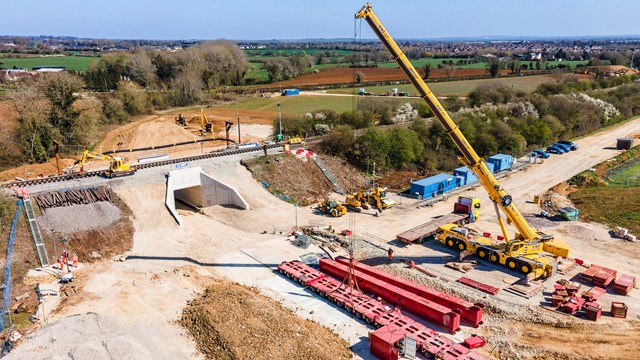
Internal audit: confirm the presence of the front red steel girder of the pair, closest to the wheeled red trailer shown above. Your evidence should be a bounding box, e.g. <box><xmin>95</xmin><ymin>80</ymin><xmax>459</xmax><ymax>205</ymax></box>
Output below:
<box><xmin>320</xmin><ymin>259</ymin><xmax>460</xmax><ymax>334</ymax></box>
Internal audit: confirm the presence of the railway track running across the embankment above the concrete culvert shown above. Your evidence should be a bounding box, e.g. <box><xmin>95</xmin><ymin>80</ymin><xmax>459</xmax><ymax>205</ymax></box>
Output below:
<box><xmin>0</xmin><ymin>144</ymin><xmax>282</xmax><ymax>189</ymax></box>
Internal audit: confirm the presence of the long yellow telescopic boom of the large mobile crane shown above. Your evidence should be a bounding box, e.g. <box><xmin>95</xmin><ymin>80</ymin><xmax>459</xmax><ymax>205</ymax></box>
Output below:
<box><xmin>356</xmin><ymin>3</ymin><xmax>551</xmax><ymax>240</ymax></box>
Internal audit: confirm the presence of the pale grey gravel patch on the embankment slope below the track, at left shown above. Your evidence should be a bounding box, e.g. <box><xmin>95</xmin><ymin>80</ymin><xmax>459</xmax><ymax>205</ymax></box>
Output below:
<box><xmin>38</xmin><ymin>201</ymin><xmax>121</xmax><ymax>235</ymax></box>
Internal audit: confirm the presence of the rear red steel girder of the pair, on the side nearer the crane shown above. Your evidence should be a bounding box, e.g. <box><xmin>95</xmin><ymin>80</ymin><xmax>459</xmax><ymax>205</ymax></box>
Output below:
<box><xmin>336</xmin><ymin>257</ymin><xmax>484</xmax><ymax>327</ymax></box>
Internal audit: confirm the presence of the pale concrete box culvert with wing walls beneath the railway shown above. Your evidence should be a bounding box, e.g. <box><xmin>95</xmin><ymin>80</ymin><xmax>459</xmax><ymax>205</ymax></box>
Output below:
<box><xmin>165</xmin><ymin>167</ymin><xmax>250</xmax><ymax>225</ymax></box>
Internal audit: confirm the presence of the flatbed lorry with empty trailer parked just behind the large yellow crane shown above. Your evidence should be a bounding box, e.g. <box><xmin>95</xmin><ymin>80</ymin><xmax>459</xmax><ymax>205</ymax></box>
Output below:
<box><xmin>396</xmin><ymin>196</ymin><xmax>480</xmax><ymax>244</ymax></box>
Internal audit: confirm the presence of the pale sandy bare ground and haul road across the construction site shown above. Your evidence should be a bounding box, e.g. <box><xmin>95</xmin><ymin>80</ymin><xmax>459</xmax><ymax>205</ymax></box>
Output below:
<box><xmin>3</xmin><ymin>114</ymin><xmax>640</xmax><ymax>359</ymax></box>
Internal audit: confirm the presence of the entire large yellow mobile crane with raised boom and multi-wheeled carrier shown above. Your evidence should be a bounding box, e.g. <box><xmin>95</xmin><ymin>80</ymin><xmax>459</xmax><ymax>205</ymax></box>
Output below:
<box><xmin>355</xmin><ymin>3</ymin><xmax>569</xmax><ymax>278</ymax></box>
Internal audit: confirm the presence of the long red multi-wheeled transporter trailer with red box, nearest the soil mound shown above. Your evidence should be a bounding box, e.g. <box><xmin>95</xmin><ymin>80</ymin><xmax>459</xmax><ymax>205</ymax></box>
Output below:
<box><xmin>278</xmin><ymin>261</ymin><xmax>485</xmax><ymax>360</ymax></box>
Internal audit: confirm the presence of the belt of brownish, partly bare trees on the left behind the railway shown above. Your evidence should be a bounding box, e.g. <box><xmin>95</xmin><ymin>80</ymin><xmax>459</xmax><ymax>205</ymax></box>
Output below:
<box><xmin>0</xmin><ymin>41</ymin><xmax>249</xmax><ymax>168</ymax></box>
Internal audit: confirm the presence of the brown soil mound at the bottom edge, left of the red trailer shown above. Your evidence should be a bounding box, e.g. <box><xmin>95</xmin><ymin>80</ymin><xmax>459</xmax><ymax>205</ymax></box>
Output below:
<box><xmin>180</xmin><ymin>282</ymin><xmax>352</xmax><ymax>359</ymax></box>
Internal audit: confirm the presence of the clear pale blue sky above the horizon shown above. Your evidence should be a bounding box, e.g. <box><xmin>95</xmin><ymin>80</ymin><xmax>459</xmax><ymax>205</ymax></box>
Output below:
<box><xmin>0</xmin><ymin>0</ymin><xmax>640</xmax><ymax>40</ymax></box>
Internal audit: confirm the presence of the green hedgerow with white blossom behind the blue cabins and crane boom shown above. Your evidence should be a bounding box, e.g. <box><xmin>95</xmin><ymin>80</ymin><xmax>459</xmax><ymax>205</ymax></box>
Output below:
<box><xmin>320</xmin><ymin>79</ymin><xmax>640</xmax><ymax>172</ymax></box>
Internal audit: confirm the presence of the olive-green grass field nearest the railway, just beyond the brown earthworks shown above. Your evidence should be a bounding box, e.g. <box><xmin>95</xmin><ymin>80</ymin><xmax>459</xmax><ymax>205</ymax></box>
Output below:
<box><xmin>224</xmin><ymin>95</ymin><xmax>420</xmax><ymax>115</ymax></box>
